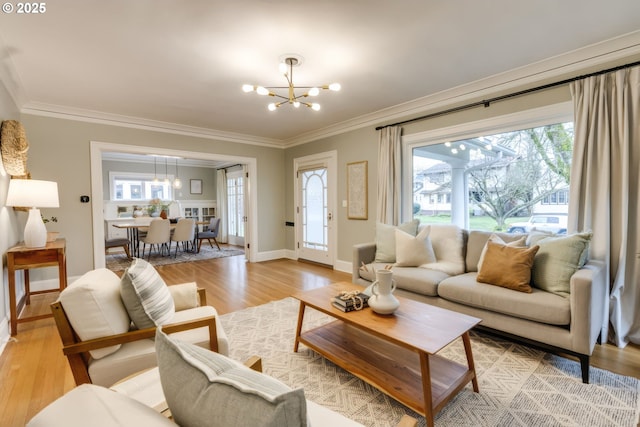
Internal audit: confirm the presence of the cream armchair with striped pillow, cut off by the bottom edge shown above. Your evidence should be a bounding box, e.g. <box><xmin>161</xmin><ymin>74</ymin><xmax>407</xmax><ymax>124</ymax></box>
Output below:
<box><xmin>27</xmin><ymin>326</ymin><xmax>417</xmax><ymax>427</ymax></box>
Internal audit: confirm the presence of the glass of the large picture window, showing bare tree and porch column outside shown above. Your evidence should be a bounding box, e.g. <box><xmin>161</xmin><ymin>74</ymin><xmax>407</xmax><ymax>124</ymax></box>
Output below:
<box><xmin>413</xmin><ymin>123</ymin><xmax>573</xmax><ymax>230</ymax></box>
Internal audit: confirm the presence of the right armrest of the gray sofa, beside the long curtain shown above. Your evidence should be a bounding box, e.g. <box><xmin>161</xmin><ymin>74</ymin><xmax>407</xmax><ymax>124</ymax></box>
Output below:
<box><xmin>569</xmin><ymin>260</ymin><xmax>607</xmax><ymax>355</ymax></box>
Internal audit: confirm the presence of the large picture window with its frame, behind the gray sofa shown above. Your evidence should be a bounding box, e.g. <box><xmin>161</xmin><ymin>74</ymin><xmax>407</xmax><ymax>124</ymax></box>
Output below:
<box><xmin>403</xmin><ymin>106</ymin><xmax>573</xmax><ymax>230</ymax></box>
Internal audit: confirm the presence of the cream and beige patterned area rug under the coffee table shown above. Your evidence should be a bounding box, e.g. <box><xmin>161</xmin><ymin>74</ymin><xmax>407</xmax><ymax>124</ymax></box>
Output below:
<box><xmin>221</xmin><ymin>298</ymin><xmax>640</xmax><ymax>427</ymax></box>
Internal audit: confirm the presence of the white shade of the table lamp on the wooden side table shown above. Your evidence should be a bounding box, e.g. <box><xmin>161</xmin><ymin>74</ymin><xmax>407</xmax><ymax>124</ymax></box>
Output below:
<box><xmin>7</xmin><ymin>179</ymin><xmax>60</xmax><ymax>208</ymax></box>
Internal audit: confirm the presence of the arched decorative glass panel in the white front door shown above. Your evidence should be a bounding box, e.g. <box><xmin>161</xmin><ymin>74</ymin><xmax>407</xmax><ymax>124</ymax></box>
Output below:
<box><xmin>302</xmin><ymin>168</ymin><xmax>328</xmax><ymax>251</ymax></box>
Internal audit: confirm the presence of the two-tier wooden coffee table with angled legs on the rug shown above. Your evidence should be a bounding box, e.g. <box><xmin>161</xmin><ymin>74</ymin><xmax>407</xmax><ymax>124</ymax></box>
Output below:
<box><xmin>292</xmin><ymin>282</ymin><xmax>481</xmax><ymax>426</ymax></box>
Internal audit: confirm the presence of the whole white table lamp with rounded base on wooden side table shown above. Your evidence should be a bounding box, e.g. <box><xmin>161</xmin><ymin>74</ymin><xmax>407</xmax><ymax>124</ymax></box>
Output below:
<box><xmin>6</xmin><ymin>179</ymin><xmax>60</xmax><ymax>248</ymax></box>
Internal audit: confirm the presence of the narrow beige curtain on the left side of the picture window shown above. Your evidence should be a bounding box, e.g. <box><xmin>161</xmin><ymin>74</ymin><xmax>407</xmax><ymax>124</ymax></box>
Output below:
<box><xmin>377</xmin><ymin>126</ymin><xmax>402</xmax><ymax>225</ymax></box>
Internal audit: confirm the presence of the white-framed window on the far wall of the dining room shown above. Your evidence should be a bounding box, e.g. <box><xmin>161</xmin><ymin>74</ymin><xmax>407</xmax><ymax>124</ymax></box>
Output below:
<box><xmin>109</xmin><ymin>172</ymin><xmax>173</xmax><ymax>201</ymax></box>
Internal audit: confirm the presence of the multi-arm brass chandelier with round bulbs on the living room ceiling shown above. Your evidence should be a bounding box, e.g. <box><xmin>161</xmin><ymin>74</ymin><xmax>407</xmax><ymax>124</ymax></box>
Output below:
<box><xmin>242</xmin><ymin>56</ymin><xmax>340</xmax><ymax>111</ymax></box>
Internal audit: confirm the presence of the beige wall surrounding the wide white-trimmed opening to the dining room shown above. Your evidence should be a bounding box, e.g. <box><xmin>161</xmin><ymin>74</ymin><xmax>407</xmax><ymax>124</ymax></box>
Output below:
<box><xmin>21</xmin><ymin>114</ymin><xmax>285</xmax><ymax>280</ymax></box>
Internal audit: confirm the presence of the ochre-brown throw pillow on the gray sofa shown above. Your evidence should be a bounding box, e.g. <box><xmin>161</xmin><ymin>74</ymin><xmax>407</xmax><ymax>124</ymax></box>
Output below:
<box><xmin>477</xmin><ymin>242</ymin><xmax>539</xmax><ymax>293</ymax></box>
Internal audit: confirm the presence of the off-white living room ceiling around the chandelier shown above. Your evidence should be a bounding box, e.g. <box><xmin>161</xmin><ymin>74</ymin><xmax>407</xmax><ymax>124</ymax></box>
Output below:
<box><xmin>0</xmin><ymin>0</ymin><xmax>640</xmax><ymax>144</ymax></box>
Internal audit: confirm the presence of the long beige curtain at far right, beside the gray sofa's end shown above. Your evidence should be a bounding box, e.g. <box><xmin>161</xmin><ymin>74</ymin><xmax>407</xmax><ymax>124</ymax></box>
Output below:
<box><xmin>569</xmin><ymin>67</ymin><xmax>640</xmax><ymax>347</ymax></box>
